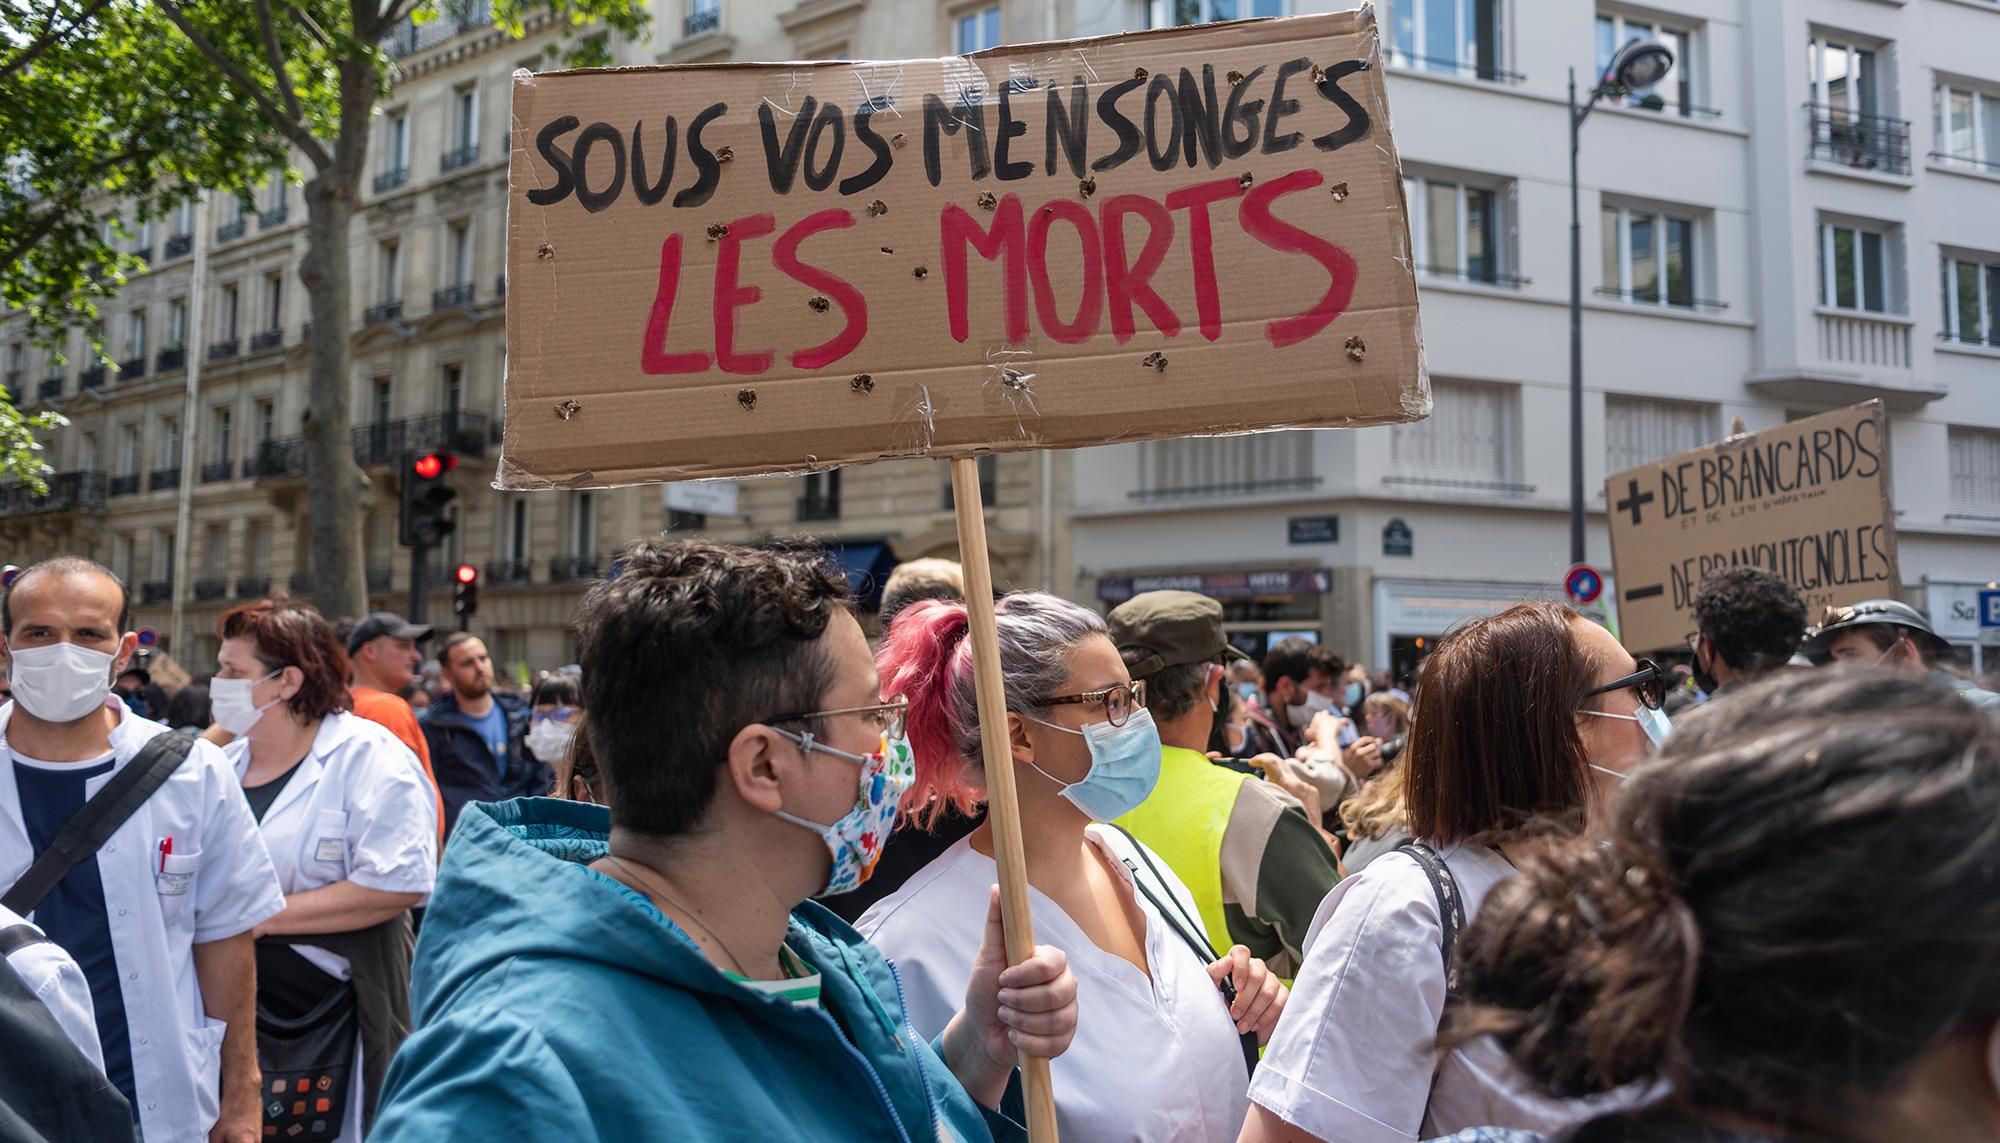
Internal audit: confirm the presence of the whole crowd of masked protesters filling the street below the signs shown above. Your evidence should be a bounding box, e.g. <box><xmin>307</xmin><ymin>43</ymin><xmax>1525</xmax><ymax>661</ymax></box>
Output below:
<box><xmin>0</xmin><ymin>536</ymin><xmax>2000</xmax><ymax>1143</ymax></box>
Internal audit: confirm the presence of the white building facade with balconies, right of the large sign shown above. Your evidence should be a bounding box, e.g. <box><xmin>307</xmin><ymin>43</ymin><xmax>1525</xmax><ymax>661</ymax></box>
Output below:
<box><xmin>1072</xmin><ymin>0</ymin><xmax>2000</xmax><ymax>667</ymax></box>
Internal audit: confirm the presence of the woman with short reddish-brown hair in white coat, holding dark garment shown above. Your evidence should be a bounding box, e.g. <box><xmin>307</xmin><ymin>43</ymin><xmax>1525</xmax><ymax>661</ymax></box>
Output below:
<box><xmin>210</xmin><ymin>595</ymin><xmax>438</xmax><ymax>1141</ymax></box>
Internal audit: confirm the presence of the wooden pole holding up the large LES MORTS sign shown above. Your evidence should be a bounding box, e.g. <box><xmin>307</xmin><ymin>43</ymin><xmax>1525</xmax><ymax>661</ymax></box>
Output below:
<box><xmin>952</xmin><ymin>458</ymin><xmax>1056</xmax><ymax>1143</ymax></box>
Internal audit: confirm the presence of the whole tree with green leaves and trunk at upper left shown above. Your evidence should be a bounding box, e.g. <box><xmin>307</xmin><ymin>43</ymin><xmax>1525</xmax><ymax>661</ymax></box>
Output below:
<box><xmin>0</xmin><ymin>0</ymin><xmax>648</xmax><ymax>615</ymax></box>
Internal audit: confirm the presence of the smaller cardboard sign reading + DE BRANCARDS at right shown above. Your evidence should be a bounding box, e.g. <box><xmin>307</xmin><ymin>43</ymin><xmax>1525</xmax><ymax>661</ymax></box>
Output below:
<box><xmin>1604</xmin><ymin>402</ymin><xmax>1902</xmax><ymax>651</ymax></box>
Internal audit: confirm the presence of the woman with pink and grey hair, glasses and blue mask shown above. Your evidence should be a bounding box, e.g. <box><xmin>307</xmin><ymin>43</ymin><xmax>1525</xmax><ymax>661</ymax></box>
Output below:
<box><xmin>858</xmin><ymin>591</ymin><xmax>1286</xmax><ymax>1141</ymax></box>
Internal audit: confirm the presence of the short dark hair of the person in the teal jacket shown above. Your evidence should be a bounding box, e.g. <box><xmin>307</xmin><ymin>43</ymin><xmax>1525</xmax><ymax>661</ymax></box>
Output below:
<box><xmin>578</xmin><ymin>534</ymin><xmax>854</xmax><ymax>837</ymax></box>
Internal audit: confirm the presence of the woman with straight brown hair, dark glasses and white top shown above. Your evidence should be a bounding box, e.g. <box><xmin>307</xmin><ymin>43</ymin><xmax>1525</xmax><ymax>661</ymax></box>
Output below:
<box><xmin>1242</xmin><ymin>603</ymin><xmax>1664</xmax><ymax>1143</ymax></box>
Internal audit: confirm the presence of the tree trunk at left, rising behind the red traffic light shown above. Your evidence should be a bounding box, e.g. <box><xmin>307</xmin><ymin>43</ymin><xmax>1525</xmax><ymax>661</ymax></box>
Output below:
<box><xmin>298</xmin><ymin>60</ymin><xmax>378</xmax><ymax>617</ymax></box>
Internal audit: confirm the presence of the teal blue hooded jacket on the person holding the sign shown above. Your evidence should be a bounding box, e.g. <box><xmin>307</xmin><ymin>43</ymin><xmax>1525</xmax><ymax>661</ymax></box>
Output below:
<box><xmin>368</xmin><ymin>797</ymin><xmax>1026</xmax><ymax>1143</ymax></box>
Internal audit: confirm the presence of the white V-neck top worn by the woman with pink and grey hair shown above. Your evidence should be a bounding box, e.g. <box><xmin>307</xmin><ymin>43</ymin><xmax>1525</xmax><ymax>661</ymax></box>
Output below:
<box><xmin>856</xmin><ymin>825</ymin><xmax>1250</xmax><ymax>1143</ymax></box>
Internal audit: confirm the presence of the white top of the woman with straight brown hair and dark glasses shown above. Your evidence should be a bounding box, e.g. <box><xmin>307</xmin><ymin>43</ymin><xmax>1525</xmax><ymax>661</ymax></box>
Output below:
<box><xmin>1250</xmin><ymin>845</ymin><xmax>1630</xmax><ymax>1143</ymax></box>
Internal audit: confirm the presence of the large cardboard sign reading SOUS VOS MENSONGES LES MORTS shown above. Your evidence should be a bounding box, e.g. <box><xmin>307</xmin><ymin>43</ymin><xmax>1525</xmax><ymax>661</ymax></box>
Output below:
<box><xmin>508</xmin><ymin>8</ymin><xmax>1430</xmax><ymax>490</ymax></box>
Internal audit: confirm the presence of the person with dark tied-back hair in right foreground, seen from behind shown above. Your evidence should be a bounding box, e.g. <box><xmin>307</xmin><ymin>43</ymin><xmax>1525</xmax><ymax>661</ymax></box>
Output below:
<box><xmin>1424</xmin><ymin>671</ymin><xmax>2000</xmax><ymax>1143</ymax></box>
